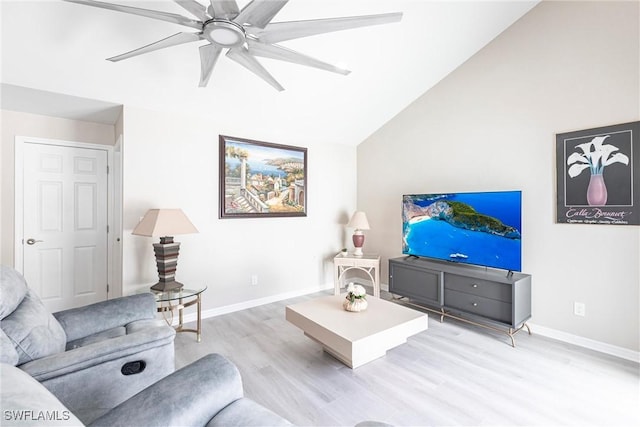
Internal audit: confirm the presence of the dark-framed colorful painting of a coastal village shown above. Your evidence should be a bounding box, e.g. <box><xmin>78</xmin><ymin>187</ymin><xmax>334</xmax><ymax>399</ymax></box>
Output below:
<box><xmin>219</xmin><ymin>135</ymin><xmax>307</xmax><ymax>218</ymax></box>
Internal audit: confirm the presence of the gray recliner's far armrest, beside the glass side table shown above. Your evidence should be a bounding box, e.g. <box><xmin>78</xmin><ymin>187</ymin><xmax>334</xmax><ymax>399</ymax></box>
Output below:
<box><xmin>53</xmin><ymin>292</ymin><xmax>157</xmax><ymax>342</ymax></box>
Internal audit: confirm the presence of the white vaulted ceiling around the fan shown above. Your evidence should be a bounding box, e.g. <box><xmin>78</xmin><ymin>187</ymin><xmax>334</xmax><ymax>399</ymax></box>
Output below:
<box><xmin>0</xmin><ymin>0</ymin><xmax>538</xmax><ymax>145</ymax></box>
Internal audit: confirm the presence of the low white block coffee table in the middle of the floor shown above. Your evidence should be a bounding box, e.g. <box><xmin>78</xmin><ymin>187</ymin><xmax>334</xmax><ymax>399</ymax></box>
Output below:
<box><xmin>286</xmin><ymin>294</ymin><xmax>427</xmax><ymax>369</ymax></box>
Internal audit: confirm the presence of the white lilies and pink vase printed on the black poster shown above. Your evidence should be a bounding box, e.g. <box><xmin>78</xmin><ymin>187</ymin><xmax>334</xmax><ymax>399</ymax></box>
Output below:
<box><xmin>567</xmin><ymin>135</ymin><xmax>629</xmax><ymax>206</ymax></box>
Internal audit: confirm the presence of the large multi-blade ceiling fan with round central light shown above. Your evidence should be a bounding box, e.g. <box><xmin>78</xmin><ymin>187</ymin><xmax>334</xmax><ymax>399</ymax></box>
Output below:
<box><xmin>65</xmin><ymin>0</ymin><xmax>402</xmax><ymax>91</ymax></box>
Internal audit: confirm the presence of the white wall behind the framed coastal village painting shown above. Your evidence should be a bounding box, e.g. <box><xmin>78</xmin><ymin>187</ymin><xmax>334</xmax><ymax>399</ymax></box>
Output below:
<box><xmin>123</xmin><ymin>106</ymin><xmax>356</xmax><ymax>310</ymax></box>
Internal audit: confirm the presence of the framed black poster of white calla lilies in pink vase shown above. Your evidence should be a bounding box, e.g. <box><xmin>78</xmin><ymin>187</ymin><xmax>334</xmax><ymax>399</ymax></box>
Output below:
<box><xmin>556</xmin><ymin>121</ymin><xmax>640</xmax><ymax>225</ymax></box>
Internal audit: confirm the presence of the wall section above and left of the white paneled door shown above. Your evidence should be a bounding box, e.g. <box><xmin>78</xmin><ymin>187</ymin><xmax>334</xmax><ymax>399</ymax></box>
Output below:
<box><xmin>0</xmin><ymin>110</ymin><xmax>115</xmax><ymax>266</ymax></box>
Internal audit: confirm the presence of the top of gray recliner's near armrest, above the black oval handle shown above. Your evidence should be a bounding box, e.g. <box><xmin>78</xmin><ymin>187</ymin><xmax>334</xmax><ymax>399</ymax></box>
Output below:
<box><xmin>20</xmin><ymin>325</ymin><xmax>176</xmax><ymax>381</ymax></box>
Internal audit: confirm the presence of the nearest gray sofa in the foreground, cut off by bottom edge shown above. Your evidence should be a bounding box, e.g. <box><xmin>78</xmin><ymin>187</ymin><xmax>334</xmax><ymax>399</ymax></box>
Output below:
<box><xmin>0</xmin><ymin>354</ymin><xmax>290</xmax><ymax>427</ymax></box>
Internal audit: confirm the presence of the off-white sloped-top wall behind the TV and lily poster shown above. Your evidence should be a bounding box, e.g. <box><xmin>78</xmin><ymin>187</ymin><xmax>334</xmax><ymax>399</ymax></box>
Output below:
<box><xmin>358</xmin><ymin>2</ymin><xmax>640</xmax><ymax>351</ymax></box>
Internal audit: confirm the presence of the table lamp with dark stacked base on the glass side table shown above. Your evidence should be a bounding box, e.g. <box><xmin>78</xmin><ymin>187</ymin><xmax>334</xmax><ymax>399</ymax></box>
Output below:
<box><xmin>131</xmin><ymin>209</ymin><xmax>198</xmax><ymax>292</ymax></box>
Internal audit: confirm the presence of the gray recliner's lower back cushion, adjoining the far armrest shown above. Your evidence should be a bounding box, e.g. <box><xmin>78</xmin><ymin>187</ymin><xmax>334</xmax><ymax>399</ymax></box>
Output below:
<box><xmin>2</xmin><ymin>290</ymin><xmax>67</xmax><ymax>365</ymax></box>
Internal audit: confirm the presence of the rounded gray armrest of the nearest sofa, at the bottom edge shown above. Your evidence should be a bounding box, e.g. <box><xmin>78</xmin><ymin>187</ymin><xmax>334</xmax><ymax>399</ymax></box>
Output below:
<box><xmin>91</xmin><ymin>354</ymin><xmax>243</xmax><ymax>427</ymax></box>
